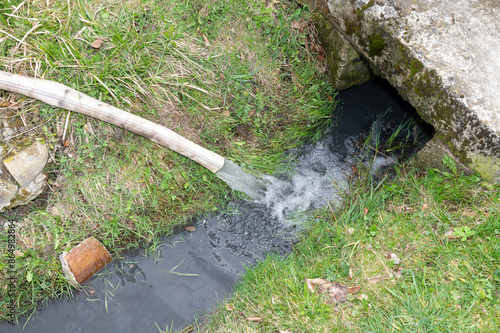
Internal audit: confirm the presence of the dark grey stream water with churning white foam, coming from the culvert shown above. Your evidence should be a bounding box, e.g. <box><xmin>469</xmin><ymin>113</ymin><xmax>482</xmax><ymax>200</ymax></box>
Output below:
<box><xmin>0</xmin><ymin>77</ymin><xmax>430</xmax><ymax>333</ymax></box>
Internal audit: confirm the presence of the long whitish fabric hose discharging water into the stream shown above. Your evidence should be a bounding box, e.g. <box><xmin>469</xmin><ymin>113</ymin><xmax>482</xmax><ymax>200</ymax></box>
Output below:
<box><xmin>0</xmin><ymin>71</ymin><xmax>224</xmax><ymax>173</ymax></box>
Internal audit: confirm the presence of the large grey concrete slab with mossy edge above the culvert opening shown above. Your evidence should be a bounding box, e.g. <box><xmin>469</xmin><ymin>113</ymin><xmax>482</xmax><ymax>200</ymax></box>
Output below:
<box><xmin>304</xmin><ymin>0</ymin><xmax>500</xmax><ymax>182</ymax></box>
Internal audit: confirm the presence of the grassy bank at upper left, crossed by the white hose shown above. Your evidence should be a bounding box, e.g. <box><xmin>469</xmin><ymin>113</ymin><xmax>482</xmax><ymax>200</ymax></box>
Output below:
<box><xmin>0</xmin><ymin>0</ymin><xmax>336</xmax><ymax>320</ymax></box>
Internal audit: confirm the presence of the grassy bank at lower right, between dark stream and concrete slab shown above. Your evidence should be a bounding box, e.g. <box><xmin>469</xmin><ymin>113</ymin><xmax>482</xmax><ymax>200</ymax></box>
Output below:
<box><xmin>197</xmin><ymin>159</ymin><xmax>500</xmax><ymax>332</ymax></box>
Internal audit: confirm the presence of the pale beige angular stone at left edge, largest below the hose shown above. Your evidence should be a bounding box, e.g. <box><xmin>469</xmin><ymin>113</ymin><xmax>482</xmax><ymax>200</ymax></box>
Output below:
<box><xmin>3</xmin><ymin>142</ymin><xmax>49</xmax><ymax>188</ymax></box>
